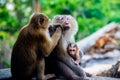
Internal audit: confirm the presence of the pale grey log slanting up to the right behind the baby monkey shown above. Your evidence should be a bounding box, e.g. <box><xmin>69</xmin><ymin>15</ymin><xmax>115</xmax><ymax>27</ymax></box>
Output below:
<box><xmin>77</xmin><ymin>22</ymin><xmax>120</xmax><ymax>52</ymax></box>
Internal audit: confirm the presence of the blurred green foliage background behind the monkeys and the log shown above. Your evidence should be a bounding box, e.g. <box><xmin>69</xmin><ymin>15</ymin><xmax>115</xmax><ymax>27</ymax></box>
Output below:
<box><xmin>0</xmin><ymin>0</ymin><xmax>120</xmax><ymax>68</ymax></box>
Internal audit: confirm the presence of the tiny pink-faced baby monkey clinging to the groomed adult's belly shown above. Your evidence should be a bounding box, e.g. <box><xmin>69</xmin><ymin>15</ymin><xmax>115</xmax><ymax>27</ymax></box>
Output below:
<box><xmin>67</xmin><ymin>43</ymin><xmax>83</xmax><ymax>65</ymax></box>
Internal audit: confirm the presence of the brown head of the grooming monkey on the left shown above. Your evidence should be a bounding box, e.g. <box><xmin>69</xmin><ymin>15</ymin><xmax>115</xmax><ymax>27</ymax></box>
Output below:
<box><xmin>29</xmin><ymin>13</ymin><xmax>49</xmax><ymax>29</ymax></box>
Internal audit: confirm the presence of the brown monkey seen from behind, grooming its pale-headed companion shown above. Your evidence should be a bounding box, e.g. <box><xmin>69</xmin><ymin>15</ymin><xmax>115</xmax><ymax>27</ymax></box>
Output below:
<box><xmin>11</xmin><ymin>13</ymin><xmax>62</xmax><ymax>80</ymax></box>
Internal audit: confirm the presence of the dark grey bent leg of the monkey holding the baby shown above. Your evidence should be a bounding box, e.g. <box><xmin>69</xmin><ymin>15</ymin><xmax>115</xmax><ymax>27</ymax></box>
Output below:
<box><xmin>57</xmin><ymin>61</ymin><xmax>88</xmax><ymax>80</ymax></box>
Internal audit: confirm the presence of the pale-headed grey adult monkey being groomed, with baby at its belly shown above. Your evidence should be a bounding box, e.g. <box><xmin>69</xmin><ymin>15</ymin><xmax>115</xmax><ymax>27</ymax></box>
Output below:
<box><xmin>45</xmin><ymin>15</ymin><xmax>88</xmax><ymax>80</ymax></box>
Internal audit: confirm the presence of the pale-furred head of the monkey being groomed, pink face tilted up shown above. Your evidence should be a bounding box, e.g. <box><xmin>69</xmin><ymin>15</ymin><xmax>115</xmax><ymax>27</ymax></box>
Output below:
<box><xmin>52</xmin><ymin>15</ymin><xmax>78</xmax><ymax>35</ymax></box>
